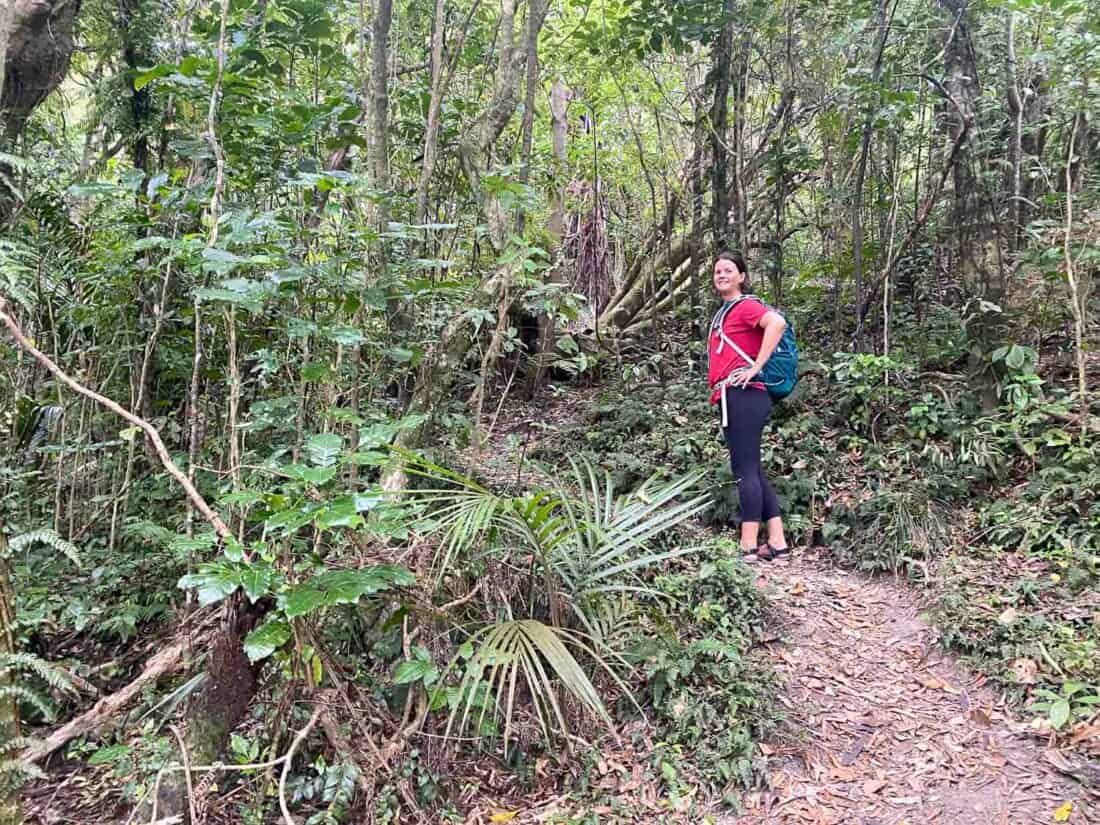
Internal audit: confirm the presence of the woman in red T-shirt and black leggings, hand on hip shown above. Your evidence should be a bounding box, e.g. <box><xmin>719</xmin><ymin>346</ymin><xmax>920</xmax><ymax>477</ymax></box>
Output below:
<box><xmin>707</xmin><ymin>251</ymin><xmax>789</xmax><ymax>561</ymax></box>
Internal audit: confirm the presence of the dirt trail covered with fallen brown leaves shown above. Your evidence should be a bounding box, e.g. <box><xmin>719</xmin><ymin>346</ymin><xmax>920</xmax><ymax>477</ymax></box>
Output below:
<box><xmin>723</xmin><ymin>553</ymin><xmax>1100</xmax><ymax>825</ymax></box>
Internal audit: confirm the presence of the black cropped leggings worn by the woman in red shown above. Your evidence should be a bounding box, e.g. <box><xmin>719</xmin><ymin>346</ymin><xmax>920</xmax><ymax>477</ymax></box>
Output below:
<box><xmin>723</xmin><ymin>387</ymin><xmax>779</xmax><ymax>521</ymax></box>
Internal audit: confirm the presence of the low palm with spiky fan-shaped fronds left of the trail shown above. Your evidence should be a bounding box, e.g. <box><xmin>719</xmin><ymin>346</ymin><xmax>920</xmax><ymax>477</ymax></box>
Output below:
<box><xmin>397</xmin><ymin>460</ymin><xmax>706</xmax><ymax>749</ymax></box>
